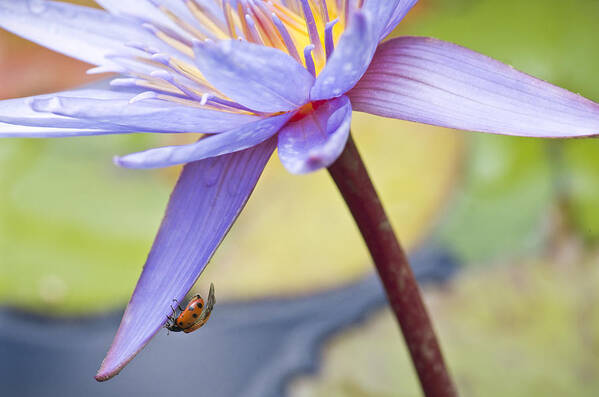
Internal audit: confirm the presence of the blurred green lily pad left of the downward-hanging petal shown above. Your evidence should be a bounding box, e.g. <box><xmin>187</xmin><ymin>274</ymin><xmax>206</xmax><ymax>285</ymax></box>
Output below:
<box><xmin>0</xmin><ymin>137</ymin><xmax>170</xmax><ymax>312</ymax></box>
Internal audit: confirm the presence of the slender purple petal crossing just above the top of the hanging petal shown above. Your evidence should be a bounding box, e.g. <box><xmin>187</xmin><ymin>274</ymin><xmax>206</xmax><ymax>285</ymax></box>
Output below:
<box><xmin>115</xmin><ymin>113</ymin><xmax>292</xmax><ymax>168</ymax></box>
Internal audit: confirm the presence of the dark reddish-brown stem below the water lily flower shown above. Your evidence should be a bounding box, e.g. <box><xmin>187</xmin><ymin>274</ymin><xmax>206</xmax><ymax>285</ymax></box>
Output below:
<box><xmin>329</xmin><ymin>136</ymin><xmax>458</xmax><ymax>397</ymax></box>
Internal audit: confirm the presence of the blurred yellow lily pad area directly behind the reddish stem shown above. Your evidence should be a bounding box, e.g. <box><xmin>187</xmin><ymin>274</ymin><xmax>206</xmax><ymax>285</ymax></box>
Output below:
<box><xmin>202</xmin><ymin>113</ymin><xmax>461</xmax><ymax>296</ymax></box>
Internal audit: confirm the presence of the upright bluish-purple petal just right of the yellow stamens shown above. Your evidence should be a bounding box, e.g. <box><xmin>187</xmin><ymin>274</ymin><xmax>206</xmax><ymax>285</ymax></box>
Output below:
<box><xmin>310</xmin><ymin>12</ymin><xmax>378</xmax><ymax>101</ymax></box>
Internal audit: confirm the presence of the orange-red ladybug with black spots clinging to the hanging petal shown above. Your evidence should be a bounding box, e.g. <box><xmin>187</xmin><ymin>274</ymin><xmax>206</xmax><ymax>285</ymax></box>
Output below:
<box><xmin>164</xmin><ymin>283</ymin><xmax>216</xmax><ymax>334</ymax></box>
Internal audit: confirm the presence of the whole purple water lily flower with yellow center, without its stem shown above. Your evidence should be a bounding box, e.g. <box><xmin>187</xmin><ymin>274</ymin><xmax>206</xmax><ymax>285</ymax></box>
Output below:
<box><xmin>0</xmin><ymin>0</ymin><xmax>599</xmax><ymax>380</ymax></box>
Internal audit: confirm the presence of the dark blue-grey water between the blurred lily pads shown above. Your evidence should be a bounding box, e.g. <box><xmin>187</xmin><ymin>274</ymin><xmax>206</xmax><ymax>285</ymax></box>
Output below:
<box><xmin>0</xmin><ymin>246</ymin><xmax>456</xmax><ymax>397</ymax></box>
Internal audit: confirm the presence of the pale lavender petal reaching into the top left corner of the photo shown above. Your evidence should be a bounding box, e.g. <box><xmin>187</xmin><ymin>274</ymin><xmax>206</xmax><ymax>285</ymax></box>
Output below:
<box><xmin>0</xmin><ymin>0</ymin><xmax>157</xmax><ymax>65</ymax></box>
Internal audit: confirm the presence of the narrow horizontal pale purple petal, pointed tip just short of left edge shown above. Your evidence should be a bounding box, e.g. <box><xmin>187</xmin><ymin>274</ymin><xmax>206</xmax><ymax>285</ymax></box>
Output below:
<box><xmin>31</xmin><ymin>95</ymin><xmax>258</xmax><ymax>133</ymax></box>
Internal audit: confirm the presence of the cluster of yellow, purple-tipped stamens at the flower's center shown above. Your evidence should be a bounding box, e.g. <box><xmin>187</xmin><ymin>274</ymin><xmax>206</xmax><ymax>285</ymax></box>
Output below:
<box><xmin>106</xmin><ymin>0</ymin><xmax>364</xmax><ymax>114</ymax></box>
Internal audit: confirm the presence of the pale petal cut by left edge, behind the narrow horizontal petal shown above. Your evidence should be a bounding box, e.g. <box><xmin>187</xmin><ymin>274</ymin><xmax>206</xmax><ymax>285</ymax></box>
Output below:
<box><xmin>0</xmin><ymin>90</ymin><xmax>136</xmax><ymax>138</ymax></box>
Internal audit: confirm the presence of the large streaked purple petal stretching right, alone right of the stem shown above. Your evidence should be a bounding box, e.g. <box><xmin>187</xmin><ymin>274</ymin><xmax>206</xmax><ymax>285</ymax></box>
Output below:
<box><xmin>349</xmin><ymin>37</ymin><xmax>599</xmax><ymax>138</ymax></box>
